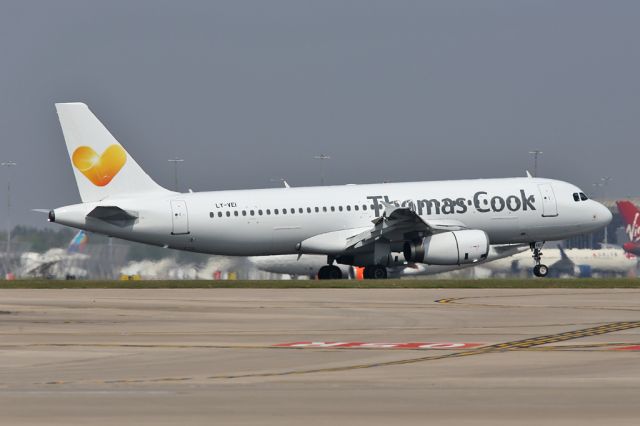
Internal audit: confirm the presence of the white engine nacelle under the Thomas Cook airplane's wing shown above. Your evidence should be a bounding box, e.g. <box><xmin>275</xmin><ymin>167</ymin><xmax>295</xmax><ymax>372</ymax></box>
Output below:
<box><xmin>404</xmin><ymin>229</ymin><xmax>489</xmax><ymax>265</ymax></box>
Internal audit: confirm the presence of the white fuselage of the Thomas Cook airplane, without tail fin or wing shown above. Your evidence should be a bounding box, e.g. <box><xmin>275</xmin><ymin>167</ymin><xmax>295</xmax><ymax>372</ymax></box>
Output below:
<box><xmin>53</xmin><ymin>178</ymin><xmax>611</xmax><ymax>256</ymax></box>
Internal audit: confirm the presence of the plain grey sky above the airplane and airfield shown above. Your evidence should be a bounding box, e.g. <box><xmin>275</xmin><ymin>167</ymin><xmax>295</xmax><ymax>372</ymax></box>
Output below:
<box><xmin>0</xmin><ymin>0</ymin><xmax>640</xmax><ymax>227</ymax></box>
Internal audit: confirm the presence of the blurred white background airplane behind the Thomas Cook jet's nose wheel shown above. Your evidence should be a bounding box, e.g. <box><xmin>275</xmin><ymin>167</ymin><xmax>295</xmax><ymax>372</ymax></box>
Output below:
<box><xmin>481</xmin><ymin>244</ymin><xmax>638</xmax><ymax>276</ymax></box>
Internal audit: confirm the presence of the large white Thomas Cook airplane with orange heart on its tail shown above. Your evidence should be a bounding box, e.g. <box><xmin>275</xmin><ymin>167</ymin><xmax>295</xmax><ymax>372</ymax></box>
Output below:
<box><xmin>43</xmin><ymin>103</ymin><xmax>611</xmax><ymax>279</ymax></box>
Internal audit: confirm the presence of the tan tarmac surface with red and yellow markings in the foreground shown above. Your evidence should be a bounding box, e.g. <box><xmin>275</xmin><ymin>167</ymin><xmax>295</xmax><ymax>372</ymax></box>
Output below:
<box><xmin>0</xmin><ymin>289</ymin><xmax>640</xmax><ymax>425</ymax></box>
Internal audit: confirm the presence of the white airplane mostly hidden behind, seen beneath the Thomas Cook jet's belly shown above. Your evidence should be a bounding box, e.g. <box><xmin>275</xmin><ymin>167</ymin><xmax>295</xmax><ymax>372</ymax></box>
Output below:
<box><xmin>249</xmin><ymin>244</ymin><xmax>529</xmax><ymax>279</ymax></box>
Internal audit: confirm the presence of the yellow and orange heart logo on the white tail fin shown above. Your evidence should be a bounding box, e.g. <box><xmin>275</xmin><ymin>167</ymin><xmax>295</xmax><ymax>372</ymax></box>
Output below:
<box><xmin>72</xmin><ymin>145</ymin><xmax>127</xmax><ymax>186</ymax></box>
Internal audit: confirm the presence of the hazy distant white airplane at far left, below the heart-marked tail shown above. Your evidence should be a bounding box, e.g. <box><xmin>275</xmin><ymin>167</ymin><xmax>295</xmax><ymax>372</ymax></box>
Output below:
<box><xmin>18</xmin><ymin>231</ymin><xmax>88</xmax><ymax>278</ymax></box>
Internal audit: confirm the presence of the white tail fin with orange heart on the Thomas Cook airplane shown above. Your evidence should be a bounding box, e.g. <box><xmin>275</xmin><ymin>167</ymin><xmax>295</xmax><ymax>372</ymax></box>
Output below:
<box><xmin>56</xmin><ymin>103</ymin><xmax>168</xmax><ymax>203</ymax></box>
